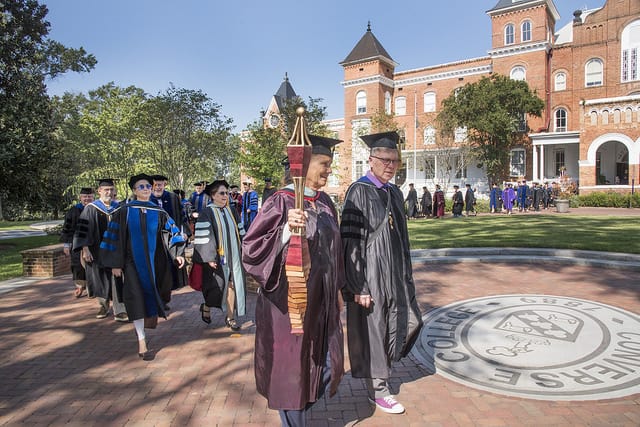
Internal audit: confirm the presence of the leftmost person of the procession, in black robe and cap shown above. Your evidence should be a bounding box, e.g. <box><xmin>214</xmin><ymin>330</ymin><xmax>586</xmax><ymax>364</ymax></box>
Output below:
<box><xmin>60</xmin><ymin>187</ymin><xmax>94</xmax><ymax>298</ymax></box>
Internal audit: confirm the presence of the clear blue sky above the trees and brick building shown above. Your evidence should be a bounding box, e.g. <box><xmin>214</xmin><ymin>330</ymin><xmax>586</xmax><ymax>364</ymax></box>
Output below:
<box><xmin>40</xmin><ymin>0</ymin><xmax>605</xmax><ymax>131</ymax></box>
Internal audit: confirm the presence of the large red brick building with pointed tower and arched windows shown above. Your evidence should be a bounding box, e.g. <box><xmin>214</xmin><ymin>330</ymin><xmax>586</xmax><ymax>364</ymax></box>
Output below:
<box><xmin>318</xmin><ymin>0</ymin><xmax>640</xmax><ymax>195</ymax></box>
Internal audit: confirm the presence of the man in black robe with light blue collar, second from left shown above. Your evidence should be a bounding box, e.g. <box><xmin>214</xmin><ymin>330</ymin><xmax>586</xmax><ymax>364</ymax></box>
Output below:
<box><xmin>73</xmin><ymin>178</ymin><xmax>129</xmax><ymax>322</ymax></box>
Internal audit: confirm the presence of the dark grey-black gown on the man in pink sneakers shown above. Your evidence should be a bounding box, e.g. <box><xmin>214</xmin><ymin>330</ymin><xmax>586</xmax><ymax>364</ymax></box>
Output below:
<box><xmin>340</xmin><ymin>177</ymin><xmax>422</xmax><ymax>378</ymax></box>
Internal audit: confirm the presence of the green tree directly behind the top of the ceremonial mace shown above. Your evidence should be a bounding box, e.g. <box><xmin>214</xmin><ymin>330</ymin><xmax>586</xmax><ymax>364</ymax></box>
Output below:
<box><xmin>238</xmin><ymin>97</ymin><xmax>330</xmax><ymax>189</ymax></box>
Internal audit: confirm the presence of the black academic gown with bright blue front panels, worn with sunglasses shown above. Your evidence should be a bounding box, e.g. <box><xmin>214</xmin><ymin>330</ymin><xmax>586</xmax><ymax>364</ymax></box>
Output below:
<box><xmin>100</xmin><ymin>201</ymin><xmax>185</xmax><ymax>320</ymax></box>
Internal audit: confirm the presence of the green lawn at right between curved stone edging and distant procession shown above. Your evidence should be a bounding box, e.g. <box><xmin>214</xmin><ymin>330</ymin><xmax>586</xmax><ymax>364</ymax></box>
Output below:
<box><xmin>409</xmin><ymin>215</ymin><xmax>640</xmax><ymax>254</ymax></box>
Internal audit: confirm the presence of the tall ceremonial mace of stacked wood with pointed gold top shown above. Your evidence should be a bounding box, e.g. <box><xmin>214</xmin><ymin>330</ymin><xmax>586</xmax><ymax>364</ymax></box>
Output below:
<box><xmin>285</xmin><ymin>107</ymin><xmax>311</xmax><ymax>335</ymax></box>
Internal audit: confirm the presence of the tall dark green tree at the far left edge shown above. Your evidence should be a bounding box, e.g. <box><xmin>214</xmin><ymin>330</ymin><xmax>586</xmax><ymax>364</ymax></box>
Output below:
<box><xmin>0</xmin><ymin>0</ymin><xmax>96</xmax><ymax>219</ymax></box>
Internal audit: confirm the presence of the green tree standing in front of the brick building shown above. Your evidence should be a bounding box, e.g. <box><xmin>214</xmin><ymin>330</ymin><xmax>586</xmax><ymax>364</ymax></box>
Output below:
<box><xmin>437</xmin><ymin>74</ymin><xmax>544</xmax><ymax>182</ymax></box>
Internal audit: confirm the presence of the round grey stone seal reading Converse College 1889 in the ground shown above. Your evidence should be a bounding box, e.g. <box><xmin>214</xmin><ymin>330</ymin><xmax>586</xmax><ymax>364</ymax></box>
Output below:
<box><xmin>412</xmin><ymin>294</ymin><xmax>640</xmax><ymax>400</ymax></box>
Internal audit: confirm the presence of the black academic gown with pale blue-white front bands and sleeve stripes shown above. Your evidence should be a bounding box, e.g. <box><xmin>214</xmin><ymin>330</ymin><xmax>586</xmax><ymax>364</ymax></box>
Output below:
<box><xmin>193</xmin><ymin>203</ymin><xmax>246</xmax><ymax>316</ymax></box>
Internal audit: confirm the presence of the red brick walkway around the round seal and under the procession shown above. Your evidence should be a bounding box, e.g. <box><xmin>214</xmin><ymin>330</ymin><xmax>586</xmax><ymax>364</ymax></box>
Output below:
<box><xmin>0</xmin><ymin>264</ymin><xmax>640</xmax><ymax>426</ymax></box>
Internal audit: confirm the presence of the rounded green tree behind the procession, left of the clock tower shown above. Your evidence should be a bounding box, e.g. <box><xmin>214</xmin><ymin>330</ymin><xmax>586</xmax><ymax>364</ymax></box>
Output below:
<box><xmin>140</xmin><ymin>85</ymin><xmax>238</xmax><ymax>189</ymax></box>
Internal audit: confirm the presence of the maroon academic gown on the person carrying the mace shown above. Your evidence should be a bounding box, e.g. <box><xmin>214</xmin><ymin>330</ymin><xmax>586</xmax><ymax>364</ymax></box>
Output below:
<box><xmin>242</xmin><ymin>190</ymin><xmax>344</xmax><ymax>410</ymax></box>
